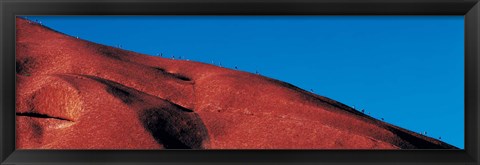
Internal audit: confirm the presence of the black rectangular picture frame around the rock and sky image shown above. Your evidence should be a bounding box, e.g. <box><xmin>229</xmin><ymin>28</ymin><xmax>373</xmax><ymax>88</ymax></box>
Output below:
<box><xmin>0</xmin><ymin>0</ymin><xmax>480</xmax><ymax>165</ymax></box>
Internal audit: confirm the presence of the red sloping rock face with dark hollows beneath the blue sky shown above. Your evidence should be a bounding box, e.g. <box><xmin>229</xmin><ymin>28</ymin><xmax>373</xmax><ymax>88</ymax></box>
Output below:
<box><xmin>16</xmin><ymin>18</ymin><xmax>455</xmax><ymax>149</ymax></box>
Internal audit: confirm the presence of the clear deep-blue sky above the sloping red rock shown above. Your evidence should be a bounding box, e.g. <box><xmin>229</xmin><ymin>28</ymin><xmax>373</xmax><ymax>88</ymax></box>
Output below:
<box><xmin>23</xmin><ymin>16</ymin><xmax>464</xmax><ymax>149</ymax></box>
